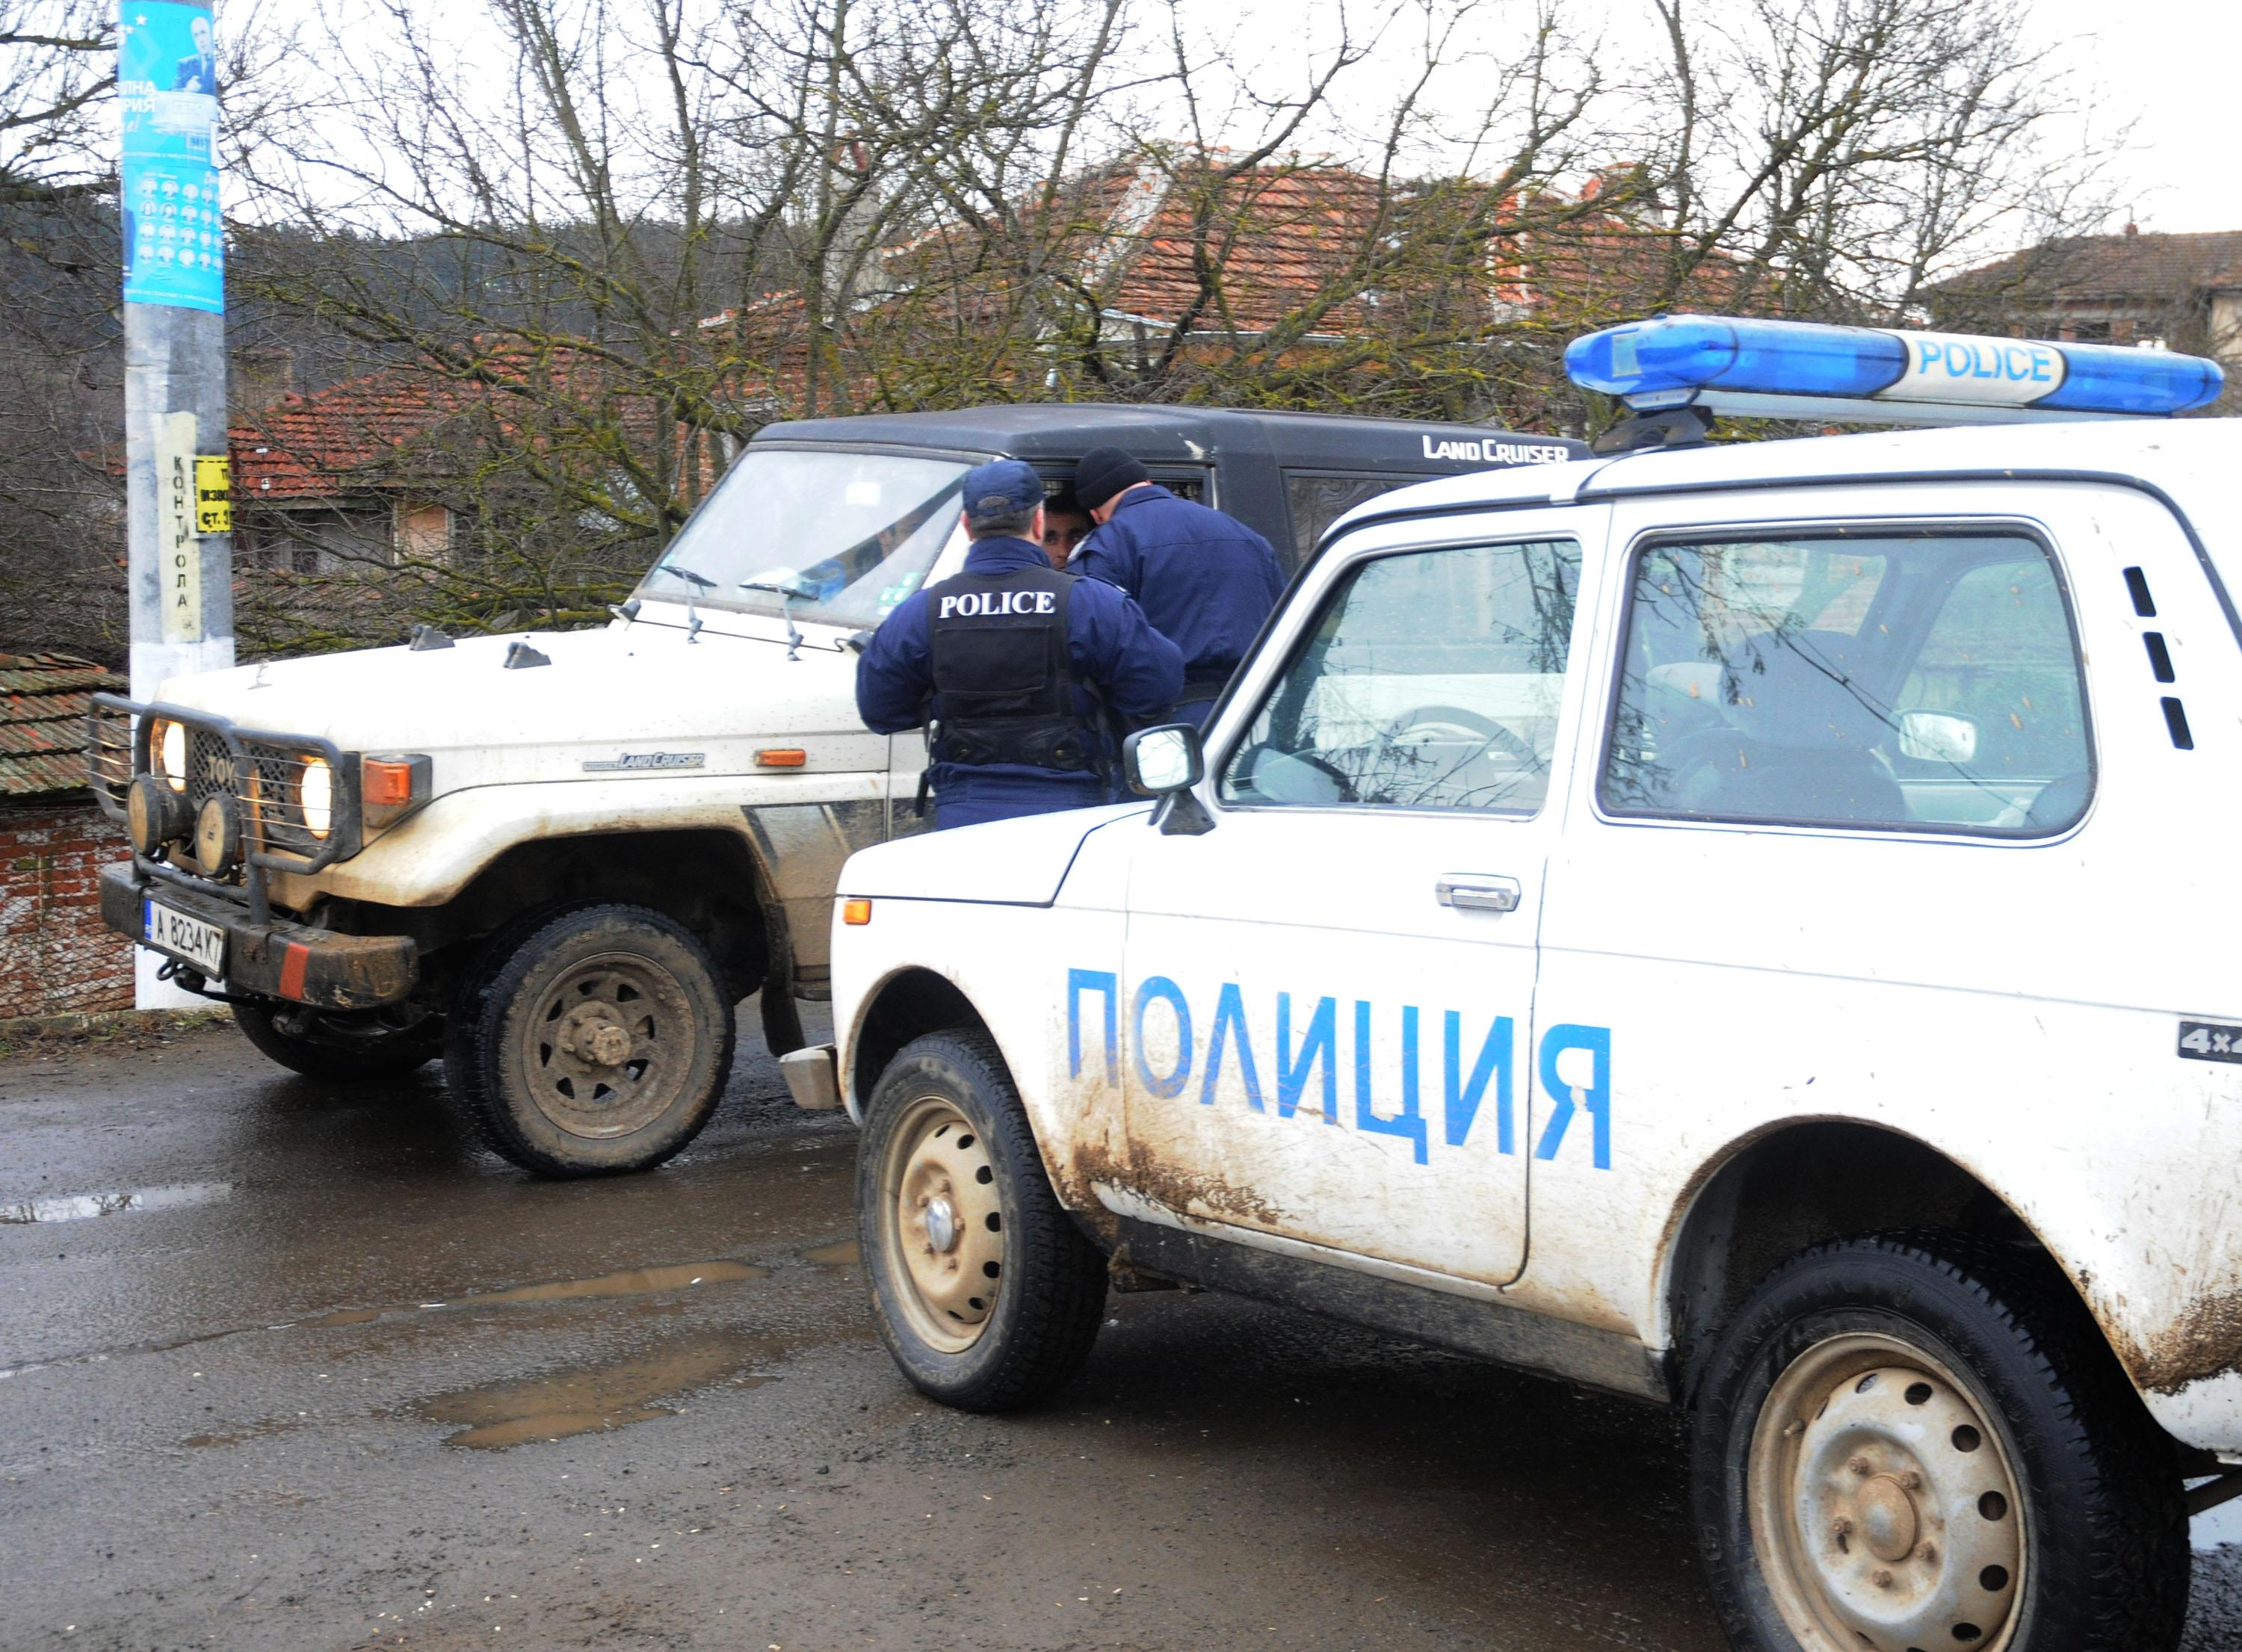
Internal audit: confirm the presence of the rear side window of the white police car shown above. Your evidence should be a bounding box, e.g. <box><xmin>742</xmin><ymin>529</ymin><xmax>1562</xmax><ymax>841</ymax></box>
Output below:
<box><xmin>1601</xmin><ymin>533</ymin><xmax>2094</xmax><ymax>836</ymax></box>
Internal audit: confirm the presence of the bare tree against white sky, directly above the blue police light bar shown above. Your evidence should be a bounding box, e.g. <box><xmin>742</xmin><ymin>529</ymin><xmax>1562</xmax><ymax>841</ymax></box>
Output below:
<box><xmin>1643</xmin><ymin>0</ymin><xmax>2107</xmax><ymax>321</ymax></box>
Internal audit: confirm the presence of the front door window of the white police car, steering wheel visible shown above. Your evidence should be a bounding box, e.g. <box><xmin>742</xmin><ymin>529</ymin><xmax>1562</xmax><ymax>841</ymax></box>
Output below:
<box><xmin>1222</xmin><ymin>542</ymin><xmax>1581</xmax><ymax>814</ymax></box>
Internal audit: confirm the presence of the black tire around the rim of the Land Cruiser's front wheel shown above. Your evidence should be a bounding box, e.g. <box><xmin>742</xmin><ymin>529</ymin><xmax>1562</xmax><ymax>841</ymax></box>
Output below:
<box><xmin>462</xmin><ymin>903</ymin><xmax>733</xmax><ymax>1177</ymax></box>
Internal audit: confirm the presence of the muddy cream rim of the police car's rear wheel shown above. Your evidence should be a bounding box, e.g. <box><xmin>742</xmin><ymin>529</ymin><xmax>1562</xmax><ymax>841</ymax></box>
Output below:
<box><xmin>1744</xmin><ymin>1331</ymin><xmax>2031</xmax><ymax>1652</ymax></box>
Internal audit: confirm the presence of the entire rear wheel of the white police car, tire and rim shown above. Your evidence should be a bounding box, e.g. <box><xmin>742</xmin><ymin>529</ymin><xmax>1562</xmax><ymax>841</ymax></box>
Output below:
<box><xmin>1693</xmin><ymin>1233</ymin><xmax>2188</xmax><ymax>1652</ymax></box>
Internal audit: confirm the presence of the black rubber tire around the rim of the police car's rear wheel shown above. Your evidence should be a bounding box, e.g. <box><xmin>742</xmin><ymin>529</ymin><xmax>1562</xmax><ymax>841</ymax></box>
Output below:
<box><xmin>1690</xmin><ymin>1231</ymin><xmax>2190</xmax><ymax>1652</ymax></box>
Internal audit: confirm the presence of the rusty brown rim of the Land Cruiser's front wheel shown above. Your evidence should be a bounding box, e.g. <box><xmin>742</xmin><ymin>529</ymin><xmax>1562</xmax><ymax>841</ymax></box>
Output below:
<box><xmin>520</xmin><ymin>953</ymin><xmax>695</xmax><ymax>1141</ymax></box>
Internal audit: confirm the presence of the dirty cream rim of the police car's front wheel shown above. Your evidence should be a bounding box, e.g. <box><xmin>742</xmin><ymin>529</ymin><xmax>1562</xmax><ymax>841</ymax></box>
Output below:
<box><xmin>879</xmin><ymin>1096</ymin><xmax>1004</xmax><ymax>1354</ymax></box>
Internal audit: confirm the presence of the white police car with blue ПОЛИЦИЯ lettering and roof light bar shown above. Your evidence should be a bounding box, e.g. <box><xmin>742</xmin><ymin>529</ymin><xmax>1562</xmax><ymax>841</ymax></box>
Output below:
<box><xmin>834</xmin><ymin>318</ymin><xmax>2242</xmax><ymax>1652</ymax></box>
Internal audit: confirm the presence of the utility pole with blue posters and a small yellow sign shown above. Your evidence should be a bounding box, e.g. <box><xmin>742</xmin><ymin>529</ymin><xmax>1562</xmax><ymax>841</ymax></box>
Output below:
<box><xmin>117</xmin><ymin>0</ymin><xmax>233</xmax><ymax>1009</ymax></box>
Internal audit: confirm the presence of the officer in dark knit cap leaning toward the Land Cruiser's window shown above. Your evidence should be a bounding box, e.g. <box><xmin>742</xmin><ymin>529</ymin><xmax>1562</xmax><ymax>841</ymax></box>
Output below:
<box><xmin>1067</xmin><ymin>448</ymin><xmax>1285</xmax><ymax>724</ymax></box>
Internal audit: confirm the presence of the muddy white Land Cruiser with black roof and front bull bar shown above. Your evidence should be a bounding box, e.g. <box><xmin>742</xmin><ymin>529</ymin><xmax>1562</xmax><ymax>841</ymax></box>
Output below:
<box><xmin>92</xmin><ymin>406</ymin><xmax>1583</xmax><ymax>1175</ymax></box>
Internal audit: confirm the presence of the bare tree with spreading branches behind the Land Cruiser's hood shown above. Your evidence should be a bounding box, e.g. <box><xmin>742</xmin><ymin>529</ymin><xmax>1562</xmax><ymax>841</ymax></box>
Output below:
<box><xmin>218</xmin><ymin>0</ymin><xmax>1148</xmax><ymax>646</ymax></box>
